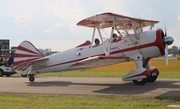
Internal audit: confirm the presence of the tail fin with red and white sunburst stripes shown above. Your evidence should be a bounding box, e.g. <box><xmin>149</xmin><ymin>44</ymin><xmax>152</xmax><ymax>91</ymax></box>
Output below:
<box><xmin>13</xmin><ymin>41</ymin><xmax>44</xmax><ymax>66</ymax></box>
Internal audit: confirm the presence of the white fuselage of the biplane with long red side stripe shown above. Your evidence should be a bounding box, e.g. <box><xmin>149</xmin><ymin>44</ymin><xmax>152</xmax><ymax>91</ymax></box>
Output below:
<box><xmin>32</xmin><ymin>30</ymin><xmax>164</xmax><ymax>71</ymax></box>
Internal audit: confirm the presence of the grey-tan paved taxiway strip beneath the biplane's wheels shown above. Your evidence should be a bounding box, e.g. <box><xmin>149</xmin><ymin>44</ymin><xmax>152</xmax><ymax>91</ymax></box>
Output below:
<box><xmin>0</xmin><ymin>77</ymin><xmax>180</xmax><ymax>96</ymax></box>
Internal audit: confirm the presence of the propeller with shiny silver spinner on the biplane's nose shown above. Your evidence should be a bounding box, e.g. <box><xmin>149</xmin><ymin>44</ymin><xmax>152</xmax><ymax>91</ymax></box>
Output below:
<box><xmin>164</xmin><ymin>22</ymin><xmax>174</xmax><ymax>65</ymax></box>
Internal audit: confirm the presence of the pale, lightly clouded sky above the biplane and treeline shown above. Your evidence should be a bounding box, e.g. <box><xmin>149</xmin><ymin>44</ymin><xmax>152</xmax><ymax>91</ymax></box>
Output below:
<box><xmin>0</xmin><ymin>0</ymin><xmax>180</xmax><ymax>51</ymax></box>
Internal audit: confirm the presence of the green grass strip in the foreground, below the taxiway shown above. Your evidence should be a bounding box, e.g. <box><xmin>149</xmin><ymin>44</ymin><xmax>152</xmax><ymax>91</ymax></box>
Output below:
<box><xmin>0</xmin><ymin>93</ymin><xmax>180</xmax><ymax>109</ymax></box>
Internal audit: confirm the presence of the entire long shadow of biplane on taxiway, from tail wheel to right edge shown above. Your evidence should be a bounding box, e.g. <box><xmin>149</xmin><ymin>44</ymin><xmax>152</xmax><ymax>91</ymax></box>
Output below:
<box><xmin>26</xmin><ymin>81</ymin><xmax>180</xmax><ymax>96</ymax></box>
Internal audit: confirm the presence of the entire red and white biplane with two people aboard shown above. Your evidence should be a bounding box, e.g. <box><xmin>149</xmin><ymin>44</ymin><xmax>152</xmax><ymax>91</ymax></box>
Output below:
<box><xmin>14</xmin><ymin>13</ymin><xmax>174</xmax><ymax>85</ymax></box>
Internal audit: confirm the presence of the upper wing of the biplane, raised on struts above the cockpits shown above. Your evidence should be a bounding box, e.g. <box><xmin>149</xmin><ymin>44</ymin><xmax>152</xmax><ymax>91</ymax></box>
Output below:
<box><xmin>77</xmin><ymin>13</ymin><xmax>159</xmax><ymax>30</ymax></box>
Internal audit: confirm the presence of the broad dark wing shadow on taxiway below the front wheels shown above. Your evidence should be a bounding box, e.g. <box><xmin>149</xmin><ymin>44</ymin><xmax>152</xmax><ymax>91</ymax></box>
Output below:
<box><xmin>93</xmin><ymin>81</ymin><xmax>180</xmax><ymax>95</ymax></box>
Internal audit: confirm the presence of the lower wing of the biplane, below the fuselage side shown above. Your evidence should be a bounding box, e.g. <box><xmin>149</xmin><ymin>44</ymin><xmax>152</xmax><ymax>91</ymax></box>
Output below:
<box><xmin>71</xmin><ymin>56</ymin><xmax>129</xmax><ymax>68</ymax></box>
